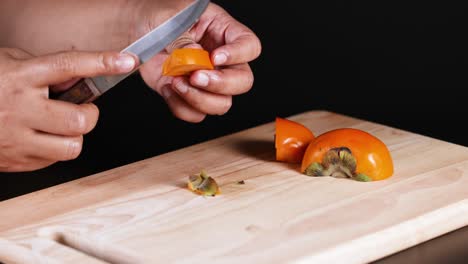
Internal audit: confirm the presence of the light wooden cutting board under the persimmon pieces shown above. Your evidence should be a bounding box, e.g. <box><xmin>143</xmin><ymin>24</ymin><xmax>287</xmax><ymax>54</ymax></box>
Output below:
<box><xmin>0</xmin><ymin>111</ymin><xmax>468</xmax><ymax>264</ymax></box>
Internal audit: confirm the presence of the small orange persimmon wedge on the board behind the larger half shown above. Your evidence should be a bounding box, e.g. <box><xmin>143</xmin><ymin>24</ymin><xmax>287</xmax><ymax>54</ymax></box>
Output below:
<box><xmin>275</xmin><ymin>117</ymin><xmax>315</xmax><ymax>163</ymax></box>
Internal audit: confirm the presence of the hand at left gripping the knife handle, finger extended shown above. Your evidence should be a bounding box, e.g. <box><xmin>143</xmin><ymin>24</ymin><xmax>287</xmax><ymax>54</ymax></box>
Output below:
<box><xmin>0</xmin><ymin>48</ymin><xmax>137</xmax><ymax>172</ymax></box>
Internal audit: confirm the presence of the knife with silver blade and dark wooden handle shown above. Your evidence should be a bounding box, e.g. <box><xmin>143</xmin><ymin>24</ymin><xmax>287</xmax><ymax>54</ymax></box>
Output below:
<box><xmin>52</xmin><ymin>0</ymin><xmax>210</xmax><ymax>104</ymax></box>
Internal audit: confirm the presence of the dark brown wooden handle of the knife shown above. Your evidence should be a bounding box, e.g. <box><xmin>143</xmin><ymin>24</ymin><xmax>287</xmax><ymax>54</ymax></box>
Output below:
<box><xmin>51</xmin><ymin>78</ymin><xmax>101</xmax><ymax>104</ymax></box>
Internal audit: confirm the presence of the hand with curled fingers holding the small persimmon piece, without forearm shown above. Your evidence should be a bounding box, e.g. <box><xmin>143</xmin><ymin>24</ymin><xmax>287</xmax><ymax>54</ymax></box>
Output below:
<box><xmin>140</xmin><ymin>3</ymin><xmax>261</xmax><ymax>122</ymax></box>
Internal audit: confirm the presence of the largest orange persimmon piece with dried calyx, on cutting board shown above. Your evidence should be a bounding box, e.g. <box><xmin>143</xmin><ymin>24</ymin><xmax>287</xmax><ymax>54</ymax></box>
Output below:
<box><xmin>301</xmin><ymin>128</ymin><xmax>393</xmax><ymax>181</ymax></box>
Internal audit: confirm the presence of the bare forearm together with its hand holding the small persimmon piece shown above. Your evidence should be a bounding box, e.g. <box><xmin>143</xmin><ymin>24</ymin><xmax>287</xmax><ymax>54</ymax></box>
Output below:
<box><xmin>0</xmin><ymin>0</ymin><xmax>261</xmax><ymax>122</ymax></box>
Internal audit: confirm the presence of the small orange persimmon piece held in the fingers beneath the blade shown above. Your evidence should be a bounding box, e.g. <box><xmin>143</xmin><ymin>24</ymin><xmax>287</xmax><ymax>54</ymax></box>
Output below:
<box><xmin>163</xmin><ymin>48</ymin><xmax>214</xmax><ymax>76</ymax></box>
